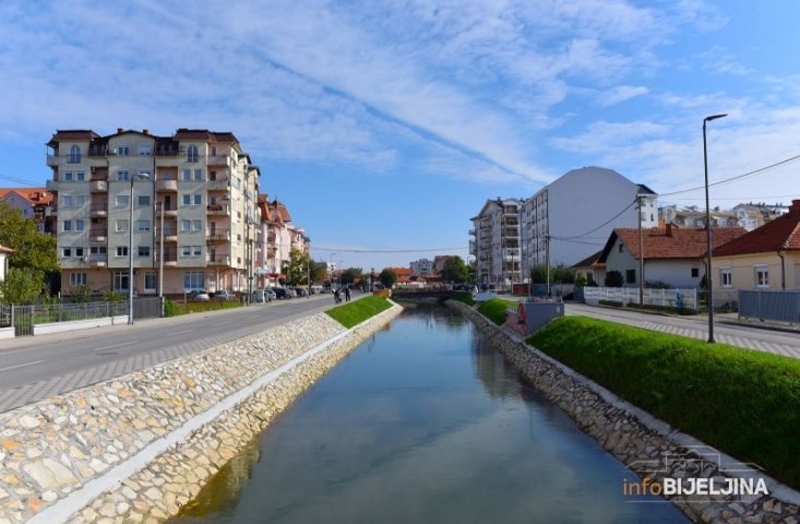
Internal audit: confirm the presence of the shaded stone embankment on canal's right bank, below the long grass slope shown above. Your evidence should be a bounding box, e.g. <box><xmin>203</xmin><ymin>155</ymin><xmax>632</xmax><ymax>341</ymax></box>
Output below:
<box><xmin>447</xmin><ymin>300</ymin><xmax>800</xmax><ymax>524</ymax></box>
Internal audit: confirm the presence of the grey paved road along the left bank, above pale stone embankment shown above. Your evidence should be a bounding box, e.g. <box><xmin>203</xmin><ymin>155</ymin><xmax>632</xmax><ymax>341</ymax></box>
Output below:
<box><xmin>0</xmin><ymin>295</ymin><xmax>346</xmax><ymax>413</ymax></box>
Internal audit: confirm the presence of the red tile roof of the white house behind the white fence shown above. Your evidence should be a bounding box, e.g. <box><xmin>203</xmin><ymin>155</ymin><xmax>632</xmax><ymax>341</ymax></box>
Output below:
<box><xmin>601</xmin><ymin>225</ymin><xmax>746</xmax><ymax>262</ymax></box>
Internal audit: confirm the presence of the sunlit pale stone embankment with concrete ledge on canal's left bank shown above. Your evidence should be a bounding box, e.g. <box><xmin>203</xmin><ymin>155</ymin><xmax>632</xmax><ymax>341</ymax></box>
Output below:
<box><xmin>0</xmin><ymin>305</ymin><xmax>401</xmax><ymax>524</ymax></box>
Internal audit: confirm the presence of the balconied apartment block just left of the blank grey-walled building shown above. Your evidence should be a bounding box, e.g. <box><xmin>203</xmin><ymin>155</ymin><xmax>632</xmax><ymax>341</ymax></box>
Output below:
<box><xmin>470</xmin><ymin>197</ymin><xmax>525</xmax><ymax>287</ymax></box>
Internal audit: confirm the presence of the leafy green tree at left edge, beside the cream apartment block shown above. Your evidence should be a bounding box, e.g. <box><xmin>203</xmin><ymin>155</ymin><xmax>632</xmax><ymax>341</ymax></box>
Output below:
<box><xmin>0</xmin><ymin>202</ymin><xmax>59</xmax><ymax>304</ymax></box>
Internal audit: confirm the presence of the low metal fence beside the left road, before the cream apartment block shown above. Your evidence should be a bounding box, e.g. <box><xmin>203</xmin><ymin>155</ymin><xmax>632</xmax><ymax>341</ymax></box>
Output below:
<box><xmin>0</xmin><ymin>297</ymin><xmax>161</xmax><ymax>337</ymax></box>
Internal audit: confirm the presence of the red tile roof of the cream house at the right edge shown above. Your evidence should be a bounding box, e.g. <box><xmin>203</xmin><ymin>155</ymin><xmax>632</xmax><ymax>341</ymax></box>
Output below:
<box><xmin>713</xmin><ymin>200</ymin><xmax>800</xmax><ymax>257</ymax></box>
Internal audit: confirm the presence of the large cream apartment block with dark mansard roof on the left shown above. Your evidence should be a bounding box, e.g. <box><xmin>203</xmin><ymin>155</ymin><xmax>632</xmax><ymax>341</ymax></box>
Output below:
<box><xmin>47</xmin><ymin>129</ymin><xmax>260</xmax><ymax>296</ymax></box>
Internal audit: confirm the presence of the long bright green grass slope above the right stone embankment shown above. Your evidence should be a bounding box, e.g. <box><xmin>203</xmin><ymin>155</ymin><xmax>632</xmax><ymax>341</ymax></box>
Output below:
<box><xmin>528</xmin><ymin>317</ymin><xmax>800</xmax><ymax>489</ymax></box>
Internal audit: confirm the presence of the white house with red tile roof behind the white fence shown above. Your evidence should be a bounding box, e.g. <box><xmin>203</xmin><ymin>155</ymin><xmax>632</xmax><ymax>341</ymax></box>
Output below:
<box><xmin>594</xmin><ymin>224</ymin><xmax>747</xmax><ymax>289</ymax></box>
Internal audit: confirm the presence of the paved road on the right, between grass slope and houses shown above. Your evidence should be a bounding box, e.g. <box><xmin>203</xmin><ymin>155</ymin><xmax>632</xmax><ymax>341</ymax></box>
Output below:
<box><xmin>565</xmin><ymin>303</ymin><xmax>800</xmax><ymax>358</ymax></box>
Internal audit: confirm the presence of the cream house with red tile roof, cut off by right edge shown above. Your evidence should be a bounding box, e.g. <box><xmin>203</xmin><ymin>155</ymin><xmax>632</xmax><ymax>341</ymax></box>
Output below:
<box><xmin>712</xmin><ymin>200</ymin><xmax>800</xmax><ymax>292</ymax></box>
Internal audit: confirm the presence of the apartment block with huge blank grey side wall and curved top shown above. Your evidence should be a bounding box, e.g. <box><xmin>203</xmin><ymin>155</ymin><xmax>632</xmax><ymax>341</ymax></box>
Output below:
<box><xmin>520</xmin><ymin>167</ymin><xmax>658</xmax><ymax>281</ymax></box>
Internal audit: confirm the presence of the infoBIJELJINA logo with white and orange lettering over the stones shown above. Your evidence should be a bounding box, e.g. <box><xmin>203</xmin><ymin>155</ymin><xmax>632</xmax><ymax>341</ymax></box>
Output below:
<box><xmin>622</xmin><ymin>446</ymin><xmax>769</xmax><ymax>502</ymax></box>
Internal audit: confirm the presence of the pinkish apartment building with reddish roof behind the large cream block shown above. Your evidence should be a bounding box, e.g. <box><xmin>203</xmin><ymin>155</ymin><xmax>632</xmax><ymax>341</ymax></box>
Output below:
<box><xmin>256</xmin><ymin>195</ymin><xmax>309</xmax><ymax>288</ymax></box>
